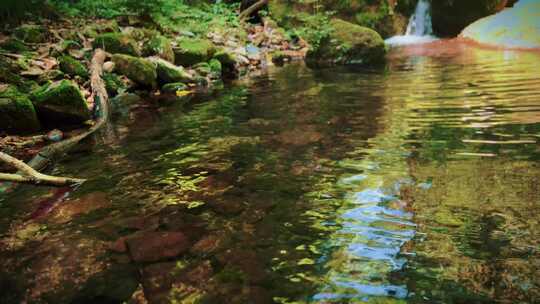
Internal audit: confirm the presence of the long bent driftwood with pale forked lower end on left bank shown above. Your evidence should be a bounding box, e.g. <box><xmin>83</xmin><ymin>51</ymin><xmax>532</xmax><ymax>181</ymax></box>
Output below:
<box><xmin>0</xmin><ymin>49</ymin><xmax>110</xmax><ymax>186</ymax></box>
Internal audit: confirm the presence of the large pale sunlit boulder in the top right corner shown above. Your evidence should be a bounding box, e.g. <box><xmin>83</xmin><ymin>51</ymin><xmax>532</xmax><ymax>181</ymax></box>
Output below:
<box><xmin>461</xmin><ymin>0</ymin><xmax>540</xmax><ymax>48</ymax></box>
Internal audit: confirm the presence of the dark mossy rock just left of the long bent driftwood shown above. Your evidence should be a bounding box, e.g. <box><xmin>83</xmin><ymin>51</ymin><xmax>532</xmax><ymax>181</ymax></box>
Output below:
<box><xmin>32</xmin><ymin>80</ymin><xmax>91</xmax><ymax>126</ymax></box>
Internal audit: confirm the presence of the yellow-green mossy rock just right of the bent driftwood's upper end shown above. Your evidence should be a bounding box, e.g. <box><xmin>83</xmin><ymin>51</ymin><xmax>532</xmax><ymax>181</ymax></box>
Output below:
<box><xmin>112</xmin><ymin>54</ymin><xmax>157</xmax><ymax>88</ymax></box>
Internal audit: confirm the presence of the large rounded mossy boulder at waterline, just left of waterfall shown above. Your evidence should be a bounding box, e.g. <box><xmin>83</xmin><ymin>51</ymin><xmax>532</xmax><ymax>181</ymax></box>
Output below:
<box><xmin>306</xmin><ymin>19</ymin><xmax>386</xmax><ymax>66</ymax></box>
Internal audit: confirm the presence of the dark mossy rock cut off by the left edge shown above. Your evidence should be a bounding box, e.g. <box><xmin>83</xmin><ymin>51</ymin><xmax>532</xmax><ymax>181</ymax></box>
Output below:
<box><xmin>0</xmin><ymin>86</ymin><xmax>40</xmax><ymax>133</ymax></box>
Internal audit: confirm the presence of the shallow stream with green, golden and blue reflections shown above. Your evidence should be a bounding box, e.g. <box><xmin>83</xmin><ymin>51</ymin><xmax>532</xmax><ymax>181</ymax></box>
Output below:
<box><xmin>0</xmin><ymin>40</ymin><xmax>540</xmax><ymax>303</ymax></box>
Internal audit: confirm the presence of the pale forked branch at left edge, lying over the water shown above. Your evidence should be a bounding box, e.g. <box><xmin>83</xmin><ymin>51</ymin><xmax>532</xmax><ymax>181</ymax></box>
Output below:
<box><xmin>0</xmin><ymin>152</ymin><xmax>85</xmax><ymax>186</ymax></box>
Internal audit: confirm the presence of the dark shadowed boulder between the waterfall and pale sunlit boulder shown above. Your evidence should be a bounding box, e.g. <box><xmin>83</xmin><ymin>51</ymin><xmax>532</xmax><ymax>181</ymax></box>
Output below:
<box><xmin>431</xmin><ymin>0</ymin><xmax>507</xmax><ymax>37</ymax></box>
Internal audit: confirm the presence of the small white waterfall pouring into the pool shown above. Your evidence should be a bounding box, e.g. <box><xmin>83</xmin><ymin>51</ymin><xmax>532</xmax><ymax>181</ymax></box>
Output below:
<box><xmin>385</xmin><ymin>0</ymin><xmax>436</xmax><ymax>45</ymax></box>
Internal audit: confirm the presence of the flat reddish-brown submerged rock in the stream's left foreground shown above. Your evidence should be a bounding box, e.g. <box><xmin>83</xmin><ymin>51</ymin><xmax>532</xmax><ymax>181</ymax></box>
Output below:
<box><xmin>126</xmin><ymin>231</ymin><xmax>190</xmax><ymax>262</ymax></box>
